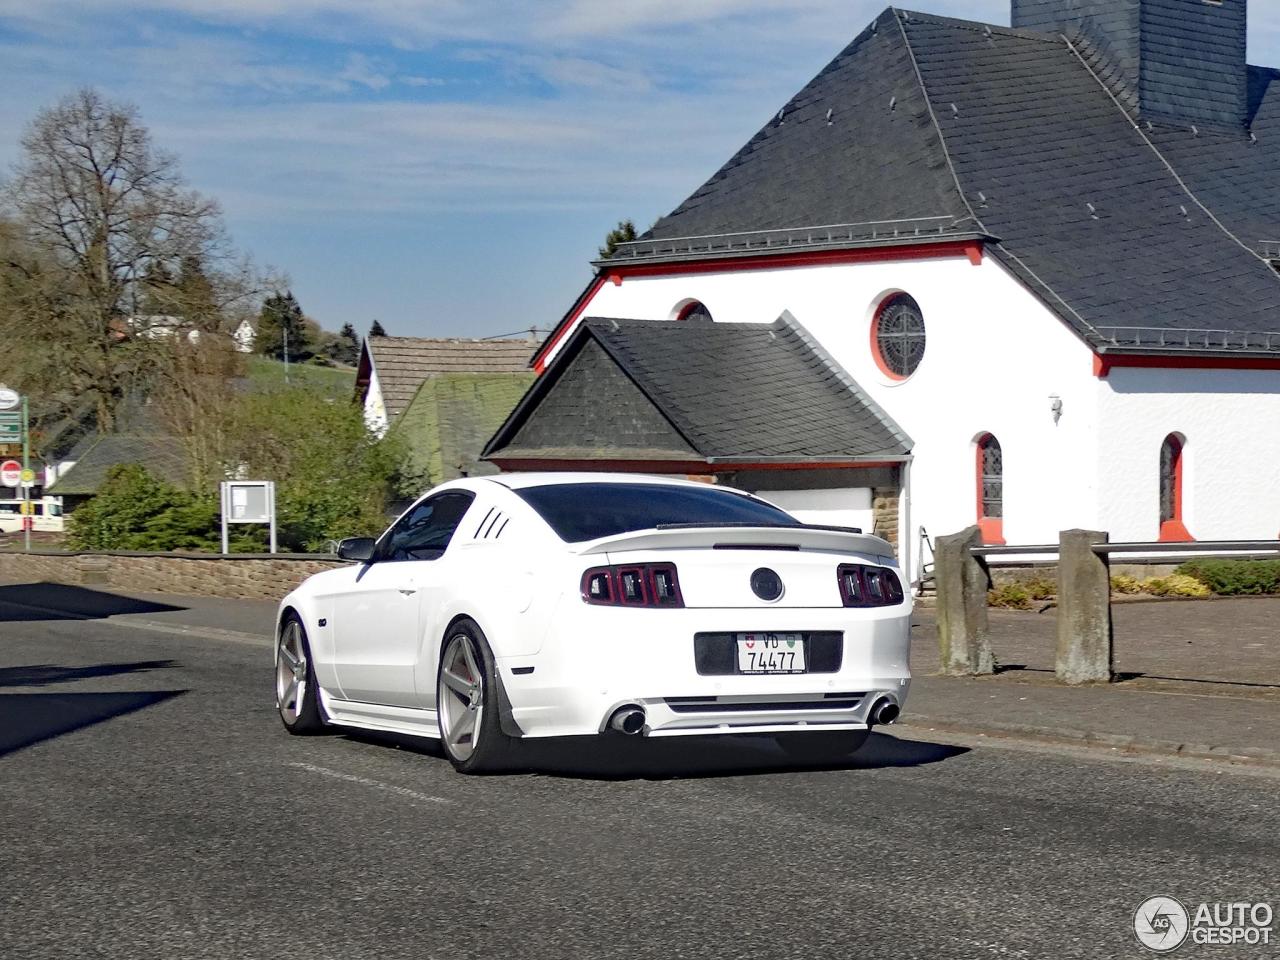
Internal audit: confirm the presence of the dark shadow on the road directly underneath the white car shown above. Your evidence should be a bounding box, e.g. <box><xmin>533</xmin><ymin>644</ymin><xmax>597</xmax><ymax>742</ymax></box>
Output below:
<box><xmin>342</xmin><ymin>730</ymin><xmax>969</xmax><ymax>780</ymax></box>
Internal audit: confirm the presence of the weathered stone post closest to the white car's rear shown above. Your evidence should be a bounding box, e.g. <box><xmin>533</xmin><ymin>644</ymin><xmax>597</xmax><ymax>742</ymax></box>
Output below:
<box><xmin>933</xmin><ymin>526</ymin><xmax>996</xmax><ymax>677</ymax></box>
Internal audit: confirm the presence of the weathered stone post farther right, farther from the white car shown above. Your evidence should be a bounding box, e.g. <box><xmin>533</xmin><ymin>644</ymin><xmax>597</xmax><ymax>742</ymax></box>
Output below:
<box><xmin>1055</xmin><ymin>530</ymin><xmax>1114</xmax><ymax>684</ymax></box>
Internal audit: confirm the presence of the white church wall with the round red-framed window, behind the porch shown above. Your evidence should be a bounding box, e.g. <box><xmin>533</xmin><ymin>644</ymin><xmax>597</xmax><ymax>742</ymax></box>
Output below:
<box><xmin>555</xmin><ymin>249</ymin><xmax>1100</xmax><ymax>578</ymax></box>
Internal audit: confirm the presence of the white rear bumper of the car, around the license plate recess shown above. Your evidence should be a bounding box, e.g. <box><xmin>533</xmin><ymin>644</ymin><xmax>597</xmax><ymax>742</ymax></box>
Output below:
<box><xmin>498</xmin><ymin>603</ymin><xmax>911</xmax><ymax>737</ymax></box>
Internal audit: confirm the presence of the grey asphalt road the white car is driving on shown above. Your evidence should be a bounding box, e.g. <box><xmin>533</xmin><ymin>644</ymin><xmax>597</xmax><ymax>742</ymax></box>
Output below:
<box><xmin>0</xmin><ymin>602</ymin><xmax>1280</xmax><ymax>960</ymax></box>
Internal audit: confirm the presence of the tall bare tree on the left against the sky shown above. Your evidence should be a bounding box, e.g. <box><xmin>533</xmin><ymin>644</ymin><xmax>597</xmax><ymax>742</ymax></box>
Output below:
<box><xmin>0</xmin><ymin>90</ymin><xmax>261</xmax><ymax>430</ymax></box>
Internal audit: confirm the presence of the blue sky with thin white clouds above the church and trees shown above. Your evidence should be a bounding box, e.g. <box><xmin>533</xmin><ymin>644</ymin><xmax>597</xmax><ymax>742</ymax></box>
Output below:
<box><xmin>0</xmin><ymin>0</ymin><xmax>1280</xmax><ymax>337</ymax></box>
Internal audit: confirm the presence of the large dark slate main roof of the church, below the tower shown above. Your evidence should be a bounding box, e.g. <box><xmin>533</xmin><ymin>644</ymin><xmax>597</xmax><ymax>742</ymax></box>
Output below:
<box><xmin>609</xmin><ymin>9</ymin><xmax>1280</xmax><ymax>353</ymax></box>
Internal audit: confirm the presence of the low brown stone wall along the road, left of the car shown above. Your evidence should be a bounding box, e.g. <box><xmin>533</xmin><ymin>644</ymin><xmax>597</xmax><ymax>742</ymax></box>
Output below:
<box><xmin>0</xmin><ymin>550</ymin><xmax>342</xmax><ymax>600</ymax></box>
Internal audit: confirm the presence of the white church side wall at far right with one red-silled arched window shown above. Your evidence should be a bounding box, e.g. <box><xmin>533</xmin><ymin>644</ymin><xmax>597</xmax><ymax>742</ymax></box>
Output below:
<box><xmin>1098</xmin><ymin>367</ymin><xmax>1280</xmax><ymax>541</ymax></box>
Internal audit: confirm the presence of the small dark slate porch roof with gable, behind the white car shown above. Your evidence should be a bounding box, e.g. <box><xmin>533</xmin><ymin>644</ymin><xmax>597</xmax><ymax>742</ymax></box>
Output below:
<box><xmin>484</xmin><ymin>314</ymin><xmax>911</xmax><ymax>463</ymax></box>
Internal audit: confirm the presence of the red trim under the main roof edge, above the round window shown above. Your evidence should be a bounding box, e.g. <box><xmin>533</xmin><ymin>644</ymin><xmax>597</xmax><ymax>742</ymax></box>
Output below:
<box><xmin>534</xmin><ymin>239</ymin><xmax>983</xmax><ymax>374</ymax></box>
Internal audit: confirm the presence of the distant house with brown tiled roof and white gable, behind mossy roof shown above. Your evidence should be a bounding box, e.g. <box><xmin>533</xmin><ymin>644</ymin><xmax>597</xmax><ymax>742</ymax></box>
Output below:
<box><xmin>356</xmin><ymin>337</ymin><xmax>539</xmax><ymax>435</ymax></box>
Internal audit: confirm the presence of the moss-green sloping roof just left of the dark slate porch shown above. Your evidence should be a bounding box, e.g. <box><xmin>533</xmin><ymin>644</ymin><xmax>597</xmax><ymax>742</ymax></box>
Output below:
<box><xmin>390</xmin><ymin>370</ymin><xmax>535</xmax><ymax>486</ymax></box>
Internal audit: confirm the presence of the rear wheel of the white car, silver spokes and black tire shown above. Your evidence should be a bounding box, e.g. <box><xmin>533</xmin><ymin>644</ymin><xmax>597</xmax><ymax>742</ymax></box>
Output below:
<box><xmin>435</xmin><ymin>620</ymin><xmax>516</xmax><ymax>773</ymax></box>
